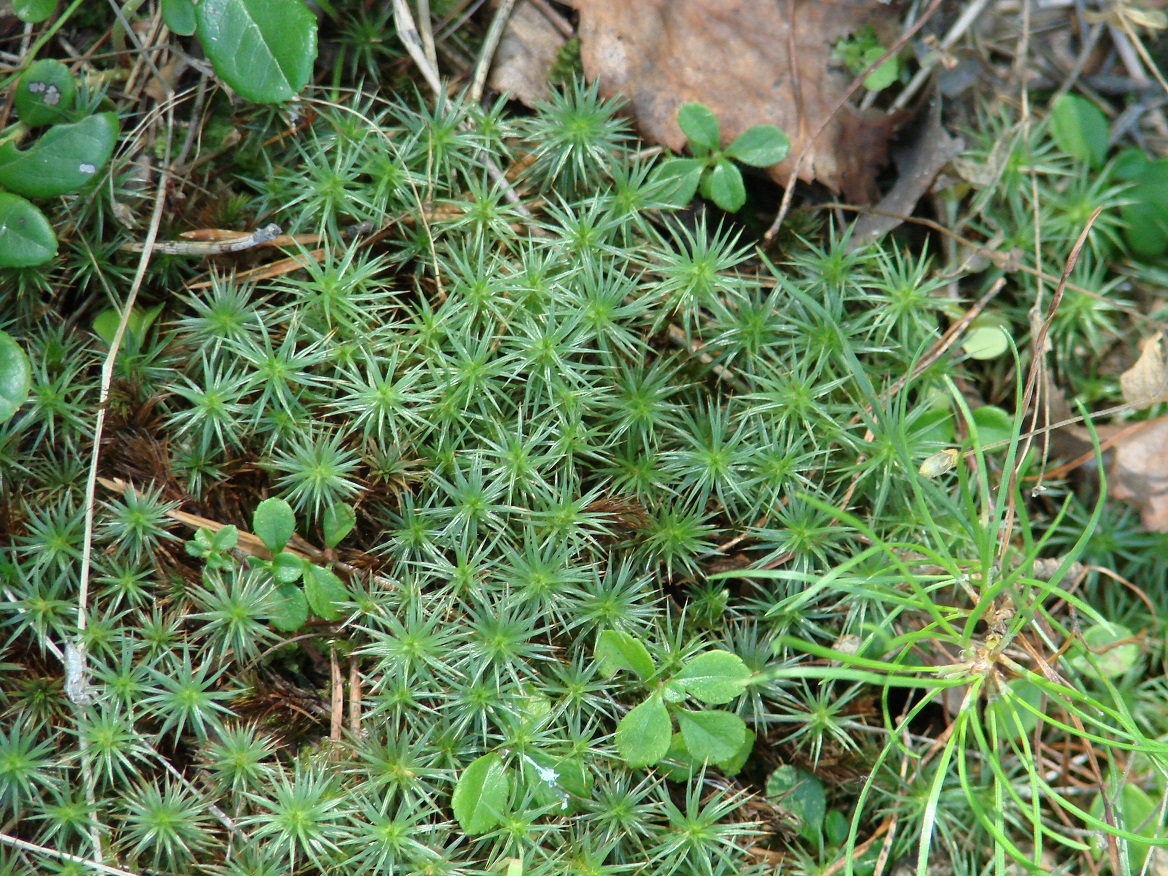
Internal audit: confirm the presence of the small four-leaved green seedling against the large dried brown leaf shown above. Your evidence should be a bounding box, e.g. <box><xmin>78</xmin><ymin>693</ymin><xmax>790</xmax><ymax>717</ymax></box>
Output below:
<box><xmin>656</xmin><ymin>104</ymin><xmax>791</xmax><ymax>213</ymax></box>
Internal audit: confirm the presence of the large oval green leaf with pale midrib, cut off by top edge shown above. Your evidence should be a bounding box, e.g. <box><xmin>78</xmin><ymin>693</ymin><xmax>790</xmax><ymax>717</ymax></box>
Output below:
<box><xmin>195</xmin><ymin>0</ymin><xmax>317</xmax><ymax>104</ymax></box>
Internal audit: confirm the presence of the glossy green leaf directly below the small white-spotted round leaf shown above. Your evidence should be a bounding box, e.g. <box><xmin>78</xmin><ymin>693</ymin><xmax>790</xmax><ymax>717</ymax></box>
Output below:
<box><xmin>0</xmin><ymin>112</ymin><xmax>118</xmax><ymax>197</ymax></box>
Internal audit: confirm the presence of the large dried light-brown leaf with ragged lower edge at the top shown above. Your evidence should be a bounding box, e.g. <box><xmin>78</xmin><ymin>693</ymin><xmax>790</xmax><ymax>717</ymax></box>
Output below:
<box><xmin>570</xmin><ymin>0</ymin><xmax>897</xmax><ymax>203</ymax></box>
